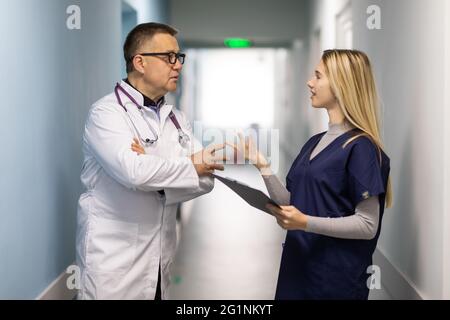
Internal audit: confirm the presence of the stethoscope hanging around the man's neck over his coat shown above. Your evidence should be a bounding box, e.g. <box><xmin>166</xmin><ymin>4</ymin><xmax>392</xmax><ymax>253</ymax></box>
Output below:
<box><xmin>114</xmin><ymin>83</ymin><xmax>190</xmax><ymax>146</ymax></box>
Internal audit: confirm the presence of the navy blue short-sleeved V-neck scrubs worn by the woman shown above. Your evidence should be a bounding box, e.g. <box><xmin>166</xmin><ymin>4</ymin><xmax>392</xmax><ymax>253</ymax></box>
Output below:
<box><xmin>275</xmin><ymin>129</ymin><xmax>390</xmax><ymax>299</ymax></box>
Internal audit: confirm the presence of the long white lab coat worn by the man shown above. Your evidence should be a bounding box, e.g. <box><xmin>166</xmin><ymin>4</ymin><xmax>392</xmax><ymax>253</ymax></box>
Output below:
<box><xmin>76</xmin><ymin>81</ymin><xmax>213</xmax><ymax>299</ymax></box>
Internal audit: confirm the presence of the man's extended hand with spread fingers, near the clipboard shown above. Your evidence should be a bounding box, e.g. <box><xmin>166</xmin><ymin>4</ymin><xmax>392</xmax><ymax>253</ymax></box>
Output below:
<box><xmin>191</xmin><ymin>143</ymin><xmax>227</xmax><ymax>177</ymax></box>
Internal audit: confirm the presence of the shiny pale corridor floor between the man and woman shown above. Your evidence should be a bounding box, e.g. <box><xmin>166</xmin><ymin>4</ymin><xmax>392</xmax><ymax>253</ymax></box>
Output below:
<box><xmin>169</xmin><ymin>166</ymin><xmax>390</xmax><ymax>300</ymax></box>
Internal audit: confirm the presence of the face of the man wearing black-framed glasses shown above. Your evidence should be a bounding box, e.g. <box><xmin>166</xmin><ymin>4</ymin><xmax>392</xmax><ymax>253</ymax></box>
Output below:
<box><xmin>138</xmin><ymin>33</ymin><xmax>182</xmax><ymax>96</ymax></box>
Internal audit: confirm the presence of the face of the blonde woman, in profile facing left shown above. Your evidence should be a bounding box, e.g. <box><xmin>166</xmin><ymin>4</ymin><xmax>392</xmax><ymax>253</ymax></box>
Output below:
<box><xmin>307</xmin><ymin>61</ymin><xmax>336</xmax><ymax>109</ymax></box>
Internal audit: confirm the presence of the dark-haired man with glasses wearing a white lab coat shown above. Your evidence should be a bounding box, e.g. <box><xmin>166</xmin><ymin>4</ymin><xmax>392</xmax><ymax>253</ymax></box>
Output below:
<box><xmin>77</xmin><ymin>23</ymin><xmax>227</xmax><ymax>299</ymax></box>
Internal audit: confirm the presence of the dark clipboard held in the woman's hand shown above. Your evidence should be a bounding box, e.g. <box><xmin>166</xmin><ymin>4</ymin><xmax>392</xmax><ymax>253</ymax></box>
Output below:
<box><xmin>212</xmin><ymin>174</ymin><xmax>281</xmax><ymax>215</ymax></box>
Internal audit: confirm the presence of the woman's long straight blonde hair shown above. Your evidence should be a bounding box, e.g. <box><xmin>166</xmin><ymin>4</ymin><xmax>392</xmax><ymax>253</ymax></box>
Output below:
<box><xmin>322</xmin><ymin>50</ymin><xmax>393</xmax><ymax>208</ymax></box>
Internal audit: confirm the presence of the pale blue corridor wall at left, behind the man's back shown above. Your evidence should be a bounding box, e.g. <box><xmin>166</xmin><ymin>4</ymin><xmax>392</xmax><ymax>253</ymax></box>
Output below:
<box><xmin>0</xmin><ymin>0</ymin><xmax>166</xmax><ymax>299</ymax></box>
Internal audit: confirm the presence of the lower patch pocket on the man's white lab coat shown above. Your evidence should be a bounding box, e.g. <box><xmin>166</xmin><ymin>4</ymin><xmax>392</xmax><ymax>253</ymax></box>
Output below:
<box><xmin>86</xmin><ymin>216</ymin><xmax>138</xmax><ymax>272</ymax></box>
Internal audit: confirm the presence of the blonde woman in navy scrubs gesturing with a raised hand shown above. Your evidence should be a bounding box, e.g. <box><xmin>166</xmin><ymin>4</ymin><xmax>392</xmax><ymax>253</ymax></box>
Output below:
<box><xmin>242</xmin><ymin>50</ymin><xmax>392</xmax><ymax>299</ymax></box>
